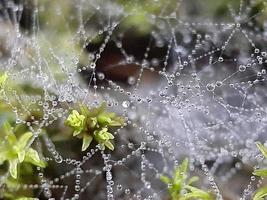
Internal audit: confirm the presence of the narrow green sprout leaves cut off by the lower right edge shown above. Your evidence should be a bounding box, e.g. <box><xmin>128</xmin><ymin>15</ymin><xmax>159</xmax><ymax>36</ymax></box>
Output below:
<box><xmin>253</xmin><ymin>142</ymin><xmax>267</xmax><ymax>200</ymax></box>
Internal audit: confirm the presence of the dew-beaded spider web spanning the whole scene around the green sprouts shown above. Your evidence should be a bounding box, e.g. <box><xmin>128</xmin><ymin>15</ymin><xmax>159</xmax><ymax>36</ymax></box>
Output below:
<box><xmin>0</xmin><ymin>0</ymin><xmax>267</xmax><ymax>199</ymax></box>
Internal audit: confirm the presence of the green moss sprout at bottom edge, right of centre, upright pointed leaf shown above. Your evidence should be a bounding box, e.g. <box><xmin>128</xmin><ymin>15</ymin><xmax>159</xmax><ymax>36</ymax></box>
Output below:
<box><xmin>160</xmin><ymin>159</ymin><xmax>213</xmax><ymax>200</ymax></box>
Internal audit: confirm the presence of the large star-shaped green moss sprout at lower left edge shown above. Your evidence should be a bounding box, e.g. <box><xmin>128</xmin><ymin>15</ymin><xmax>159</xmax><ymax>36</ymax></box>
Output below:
<box><xmin>0</xmin><ymin>122</ymin><xmax>46</xmax><ymax>179</ymax></box>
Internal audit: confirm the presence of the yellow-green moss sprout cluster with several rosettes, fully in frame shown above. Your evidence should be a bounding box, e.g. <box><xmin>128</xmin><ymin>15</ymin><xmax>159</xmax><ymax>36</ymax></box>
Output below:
<box><xmin>65</xmin><ymin>104</ymin><xmax>124</xmax><ymax>151</ymax></box>
